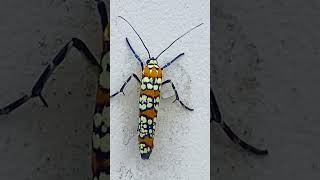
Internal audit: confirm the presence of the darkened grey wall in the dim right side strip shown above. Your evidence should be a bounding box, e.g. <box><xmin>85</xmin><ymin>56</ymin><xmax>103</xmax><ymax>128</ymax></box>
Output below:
<box><xmin>211</xmin><ymin>0</ymin><xmax>320</xmax><ymax>180</ymax></box>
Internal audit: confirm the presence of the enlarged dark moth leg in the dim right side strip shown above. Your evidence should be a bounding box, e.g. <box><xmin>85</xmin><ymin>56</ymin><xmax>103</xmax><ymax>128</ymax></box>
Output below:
<box><xmin>210</xmin><ymin>90</ymin><xmax>268</xmax><ymax>155</ymax></box>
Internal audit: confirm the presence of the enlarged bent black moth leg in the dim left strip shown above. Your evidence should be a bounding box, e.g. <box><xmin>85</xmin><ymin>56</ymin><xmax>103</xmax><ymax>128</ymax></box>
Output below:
<box><xmin>0</xmin><ymin>38</ymin><xmax>102</xmax><ymax>115</ymax></box>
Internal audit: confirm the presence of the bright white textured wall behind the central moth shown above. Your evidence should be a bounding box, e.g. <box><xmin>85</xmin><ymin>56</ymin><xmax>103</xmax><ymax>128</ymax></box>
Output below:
<box><xmin>111</xmin><ymin>0</ymin><xmax>210</xmax><ymax>179</ymax></box>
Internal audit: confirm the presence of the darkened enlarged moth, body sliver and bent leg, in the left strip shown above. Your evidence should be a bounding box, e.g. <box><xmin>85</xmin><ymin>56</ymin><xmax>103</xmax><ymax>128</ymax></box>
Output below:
<box><xmin>0</xmin><ymin>0</ymin><xmax>110</xmax><ymax>180</ymax></box>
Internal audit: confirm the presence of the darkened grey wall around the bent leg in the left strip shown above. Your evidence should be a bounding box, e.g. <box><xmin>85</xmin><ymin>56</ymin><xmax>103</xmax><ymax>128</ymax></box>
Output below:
<box><xmin>0</xmin><ymin>0</ymin><xmax>101</xmax><ymax>180</ymax></box>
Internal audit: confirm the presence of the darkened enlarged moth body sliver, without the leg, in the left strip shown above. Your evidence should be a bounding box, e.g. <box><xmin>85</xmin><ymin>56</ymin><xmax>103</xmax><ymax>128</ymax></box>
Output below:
<box><xmin>92</xmin><ymin>1</ymin><xmax>110</xmax><ymax>180</ymax></box>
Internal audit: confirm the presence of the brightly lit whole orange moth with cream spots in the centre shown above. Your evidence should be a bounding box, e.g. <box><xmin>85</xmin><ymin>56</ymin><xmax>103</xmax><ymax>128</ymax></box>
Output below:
<box><xmin>111</xmin><ymin>16</ymin><xmax>203</xmax><ymax>159</ymax></box>
